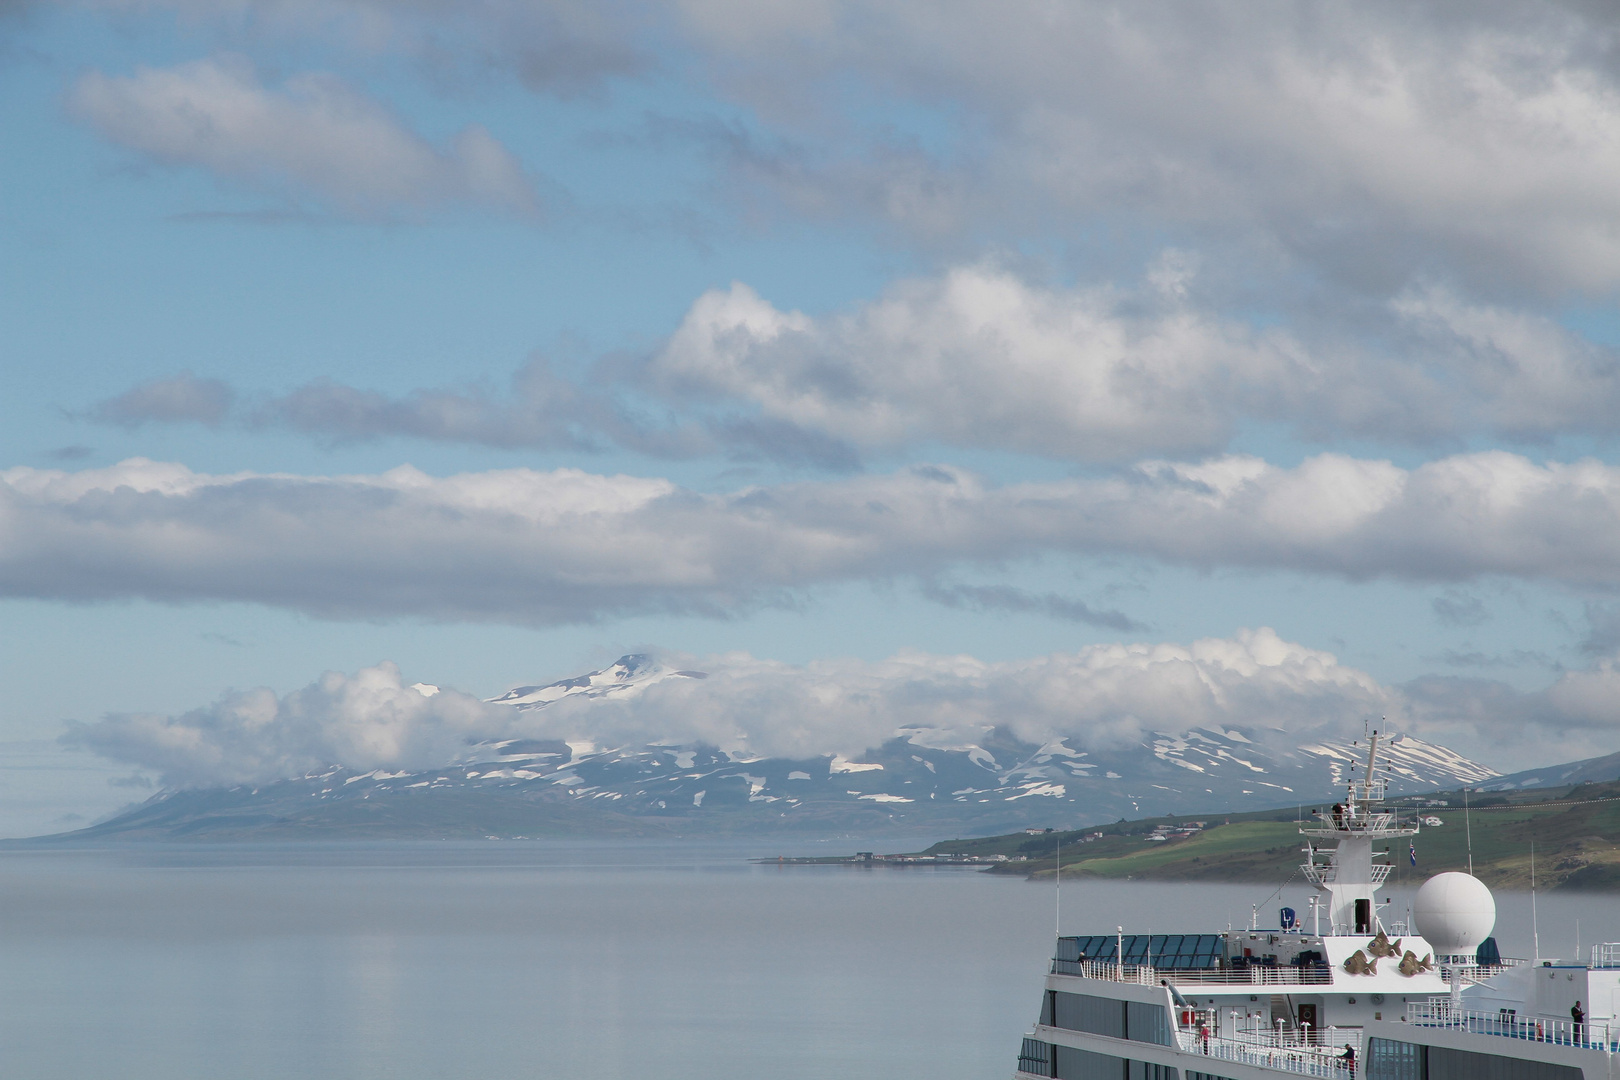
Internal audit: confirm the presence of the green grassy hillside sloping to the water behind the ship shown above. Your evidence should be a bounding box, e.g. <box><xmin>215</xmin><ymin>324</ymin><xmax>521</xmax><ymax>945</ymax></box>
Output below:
<box><xmin>928</xmin><ymin>782</ymin><xmax>1620</xmax><ymax>891</ymax></box>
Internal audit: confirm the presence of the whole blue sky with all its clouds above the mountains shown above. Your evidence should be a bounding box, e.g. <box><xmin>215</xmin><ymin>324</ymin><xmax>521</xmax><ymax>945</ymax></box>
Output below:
<box><xmin>0</xmin><ymin>0</ymin><xmax>1620</xmax><ymax>836</ymax></box>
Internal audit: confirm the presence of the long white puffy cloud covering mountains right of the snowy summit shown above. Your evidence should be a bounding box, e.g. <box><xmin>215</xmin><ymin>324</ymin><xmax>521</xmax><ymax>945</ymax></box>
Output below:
<box><xmin>533</xmin><ymin>628</ymin><xmax>1396</xmax><ymax>756</ymax></box>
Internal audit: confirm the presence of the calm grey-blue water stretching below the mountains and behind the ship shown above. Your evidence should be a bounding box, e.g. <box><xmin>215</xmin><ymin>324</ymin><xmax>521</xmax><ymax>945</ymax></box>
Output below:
<box><xmin>0</xmin><ymin>844</ymin><xmax>1620</xmax><ymax>1080</ymax></box>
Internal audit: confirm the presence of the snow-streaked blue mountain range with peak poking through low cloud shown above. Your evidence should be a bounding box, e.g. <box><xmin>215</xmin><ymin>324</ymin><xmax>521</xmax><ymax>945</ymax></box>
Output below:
<box><xmin>69</xmin><ymin>656</ymin><xmax>1497</xmax><ymax>836</ymax></box>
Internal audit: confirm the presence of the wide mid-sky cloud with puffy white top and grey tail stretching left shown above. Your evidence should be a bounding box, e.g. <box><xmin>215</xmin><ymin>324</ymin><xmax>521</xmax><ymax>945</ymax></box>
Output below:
<box><xmin>167</xmin><ymin>265</ymin><xmax>1620</xmax><ymax>471</ymax></box>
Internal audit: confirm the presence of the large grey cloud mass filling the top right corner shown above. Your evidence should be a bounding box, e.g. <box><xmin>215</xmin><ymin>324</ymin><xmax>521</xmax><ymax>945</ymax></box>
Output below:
<box><xmin>667</xmin><ymin>0</ymin><xmax>1620</xmax><ymax>291</ymax></box>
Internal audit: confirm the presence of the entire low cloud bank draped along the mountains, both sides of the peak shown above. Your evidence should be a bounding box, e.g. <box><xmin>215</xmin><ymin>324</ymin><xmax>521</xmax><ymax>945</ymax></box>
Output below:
<box><xmin>76</xmin><ymin>627</ymin><xmax>1620</xmax><ymax>787</ymax></box>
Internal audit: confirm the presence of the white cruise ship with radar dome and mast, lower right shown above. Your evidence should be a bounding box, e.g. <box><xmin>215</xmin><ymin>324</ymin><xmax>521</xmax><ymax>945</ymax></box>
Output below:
<box><xmin>1014</xmin><ymin>733</ymin><xmax>1620</xmax><ymax>1080</ymax></box>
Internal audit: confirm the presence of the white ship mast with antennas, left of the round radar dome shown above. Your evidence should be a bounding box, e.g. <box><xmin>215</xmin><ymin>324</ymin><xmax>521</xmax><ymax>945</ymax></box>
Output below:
<box><xmin>1299</xmin><ymin>732</ymin><xmax>1418</xmax><ymax>934</ymax></box>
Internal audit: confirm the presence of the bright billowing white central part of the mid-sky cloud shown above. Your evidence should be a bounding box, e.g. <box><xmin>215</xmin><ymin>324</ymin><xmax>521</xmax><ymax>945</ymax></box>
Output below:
<box><xmin>651</xmin><ymin>267</ymin><xmax>1315</xmax><ymax>460</ymax></box>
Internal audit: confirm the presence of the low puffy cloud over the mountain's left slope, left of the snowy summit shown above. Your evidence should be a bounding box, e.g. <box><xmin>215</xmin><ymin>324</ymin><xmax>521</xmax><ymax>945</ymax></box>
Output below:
<box><xmin>65</xmin><ymin>661</ymin><xmax>509</xmax><ymax>787</ymax></box>
